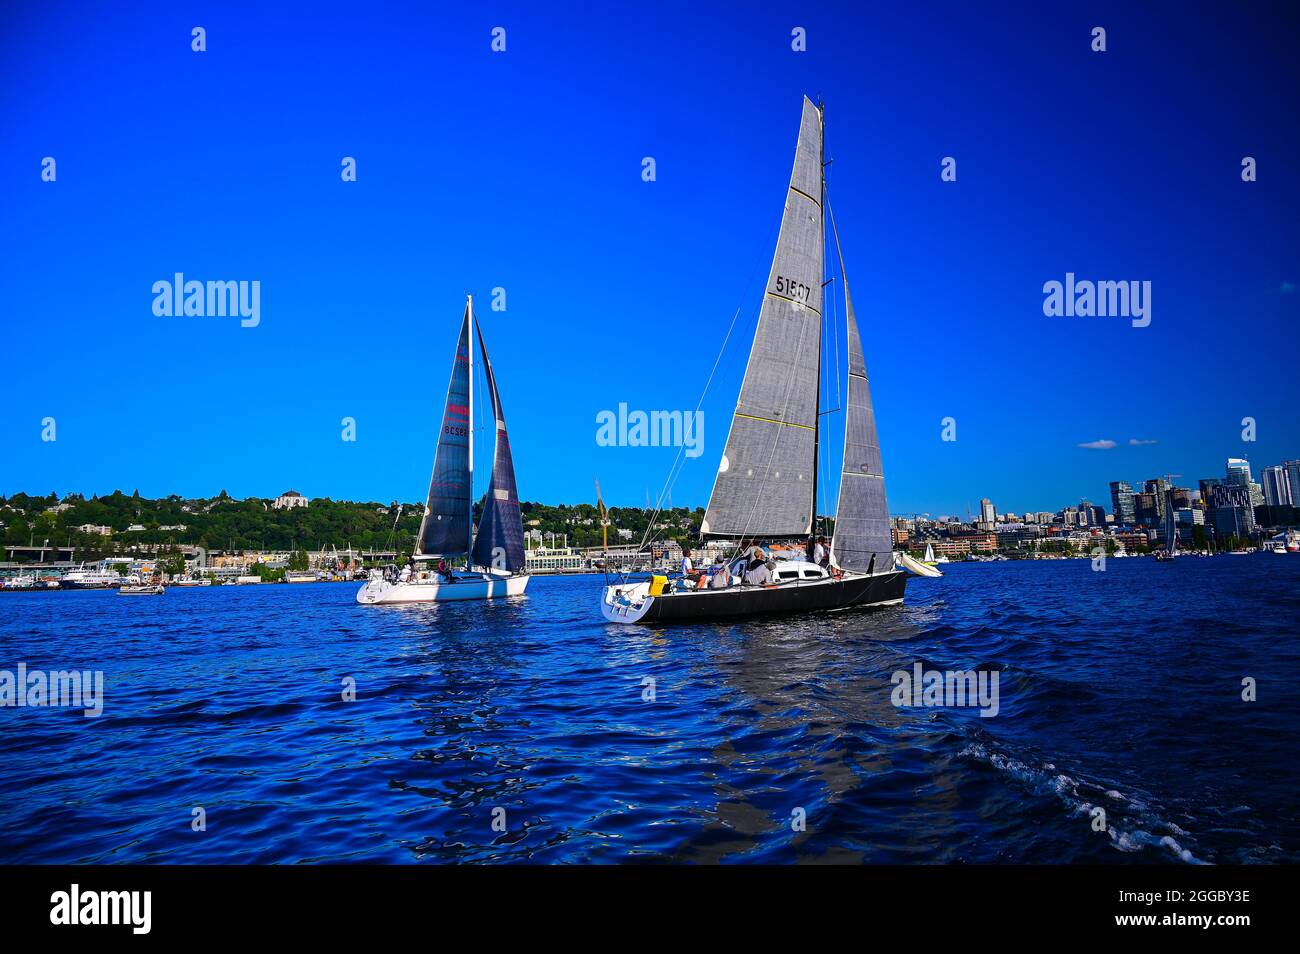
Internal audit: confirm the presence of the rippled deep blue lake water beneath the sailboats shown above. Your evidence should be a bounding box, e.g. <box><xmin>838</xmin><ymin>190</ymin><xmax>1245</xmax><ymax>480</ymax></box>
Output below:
<box><xmin>0</xmin><ymin>555</ymin><xmax>1300</xmax><ymax>864</ymax></box>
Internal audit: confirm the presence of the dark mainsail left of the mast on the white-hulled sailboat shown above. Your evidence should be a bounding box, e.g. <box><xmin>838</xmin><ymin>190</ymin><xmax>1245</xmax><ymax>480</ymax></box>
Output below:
<box><xmin>416</xmin><ymin>307</ymin><xmax>472</xmax><ymax>556</ymax></box>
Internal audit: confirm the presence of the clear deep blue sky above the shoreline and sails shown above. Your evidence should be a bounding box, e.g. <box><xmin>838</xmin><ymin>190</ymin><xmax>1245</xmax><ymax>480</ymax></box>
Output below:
<box><xmin>0</xmin><ymin>3</ymin><xmax>1300</xmax><ymax>513</ymax></box>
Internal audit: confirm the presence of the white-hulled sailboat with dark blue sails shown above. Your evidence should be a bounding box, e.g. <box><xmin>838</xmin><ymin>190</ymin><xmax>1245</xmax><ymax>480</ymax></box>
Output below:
<box><xmin>356</xmin><ymin>296</ymin><xmax>529</xmax><ymax>604</ymax></box>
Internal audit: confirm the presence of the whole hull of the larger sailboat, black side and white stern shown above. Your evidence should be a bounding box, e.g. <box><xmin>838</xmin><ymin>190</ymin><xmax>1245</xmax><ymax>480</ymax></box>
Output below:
<box><xmin>601</xmin><ymin>571</ymin><xmax>907</xmax><ymax>623</ymax></box>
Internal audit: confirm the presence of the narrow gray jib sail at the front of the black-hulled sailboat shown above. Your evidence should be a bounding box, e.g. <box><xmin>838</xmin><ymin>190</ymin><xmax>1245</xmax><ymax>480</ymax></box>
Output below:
<box><xmin>831</xmin><ymin>202</ymin><xmax>893</xmax><ymax>572</ymax></box>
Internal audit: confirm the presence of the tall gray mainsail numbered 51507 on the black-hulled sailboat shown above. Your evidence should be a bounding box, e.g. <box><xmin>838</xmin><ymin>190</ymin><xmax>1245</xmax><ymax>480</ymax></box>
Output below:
<box><xmin>701</xmin><ymin>97</ymin><xmax>824</xmax><ymax>538</ymax></box>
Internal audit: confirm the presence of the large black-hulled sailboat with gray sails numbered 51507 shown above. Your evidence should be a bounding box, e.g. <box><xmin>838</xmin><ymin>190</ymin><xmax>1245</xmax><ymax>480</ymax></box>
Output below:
<box><xmin>601</xmin><ymin>97</ymin><xmax>907</xmax><ymax>623</ymax></box>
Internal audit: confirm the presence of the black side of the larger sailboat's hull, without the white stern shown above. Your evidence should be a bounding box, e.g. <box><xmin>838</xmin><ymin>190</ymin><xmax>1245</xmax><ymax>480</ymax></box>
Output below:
<box><xmin>640</xmin><ymin>571</ymin><xmax>907</xmax><ymax>623</ymax></box>
